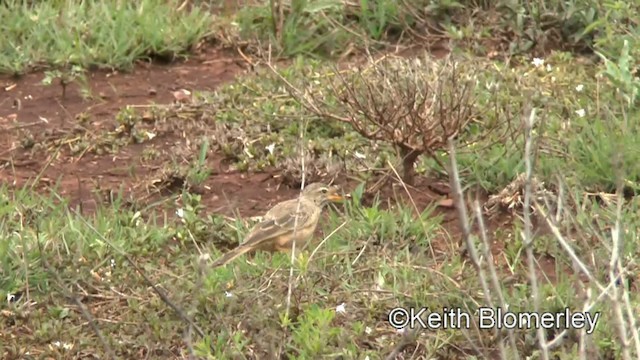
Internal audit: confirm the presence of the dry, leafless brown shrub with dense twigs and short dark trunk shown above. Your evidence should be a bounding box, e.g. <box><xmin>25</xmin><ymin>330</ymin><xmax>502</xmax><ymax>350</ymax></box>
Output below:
<box><xmin>334</xmin><ymin>56</ymin><xmax>476</xmax><ymax>184</ymax></box>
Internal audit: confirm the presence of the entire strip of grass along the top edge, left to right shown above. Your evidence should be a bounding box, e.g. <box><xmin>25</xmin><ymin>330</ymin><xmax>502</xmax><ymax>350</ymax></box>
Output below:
<box><xmin>0</xmin><ymin>0</ymin><xmax>639</xmax><ymax>74</ymax></box>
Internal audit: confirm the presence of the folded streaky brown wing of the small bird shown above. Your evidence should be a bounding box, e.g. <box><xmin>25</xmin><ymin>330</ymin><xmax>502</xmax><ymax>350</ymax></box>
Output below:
<box><xmin>242</xmin><ymin>199</ymin><xmax>312</xmax><ymax>246</ymax></box>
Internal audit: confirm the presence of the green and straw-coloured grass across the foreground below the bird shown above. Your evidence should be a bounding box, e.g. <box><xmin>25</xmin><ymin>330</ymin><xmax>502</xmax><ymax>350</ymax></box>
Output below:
<box><xmin>0</xmin><ymin>172</ymin><xmax>640</xmax><ymax>359</ymax></box>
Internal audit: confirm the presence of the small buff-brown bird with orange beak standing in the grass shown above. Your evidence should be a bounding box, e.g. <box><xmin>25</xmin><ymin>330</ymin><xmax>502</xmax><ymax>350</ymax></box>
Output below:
<box><xmin>212</xmin><ymin>183</ymin><xmax>344</xmax><ymax>268</ymax></box>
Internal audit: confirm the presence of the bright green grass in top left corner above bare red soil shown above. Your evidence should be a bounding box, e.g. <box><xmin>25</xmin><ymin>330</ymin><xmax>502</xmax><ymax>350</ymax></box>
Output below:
<box><xmin>0</xmin><ymin>0</ymin><xmax>212</xmax><ymax>74</ymax></box>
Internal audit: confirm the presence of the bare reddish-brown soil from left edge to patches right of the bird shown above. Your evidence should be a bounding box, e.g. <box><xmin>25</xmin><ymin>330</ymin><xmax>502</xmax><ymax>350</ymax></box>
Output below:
<box><xmin>0</xmin><ymin>44</ymin><xmax>555</xmax><ymax>277</ymax></box>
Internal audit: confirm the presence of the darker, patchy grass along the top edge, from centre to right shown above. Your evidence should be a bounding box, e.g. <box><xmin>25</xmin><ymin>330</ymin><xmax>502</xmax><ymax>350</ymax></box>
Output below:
<box><xmin>235</xmin><ymin>0</ymin><xmax>639</xmax><ymax>61</ymax></box>
